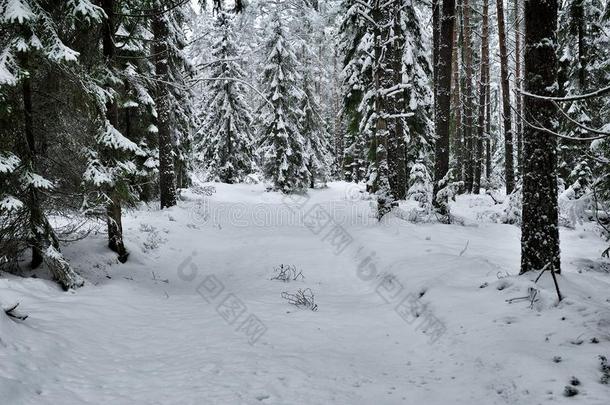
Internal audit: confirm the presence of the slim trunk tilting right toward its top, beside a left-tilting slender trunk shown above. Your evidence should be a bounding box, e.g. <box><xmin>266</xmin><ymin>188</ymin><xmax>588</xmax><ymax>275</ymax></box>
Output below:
<box><xmin>472</xmin><ymin>0</ymin><xmax>489</xmax><ymax>194</ymax></box>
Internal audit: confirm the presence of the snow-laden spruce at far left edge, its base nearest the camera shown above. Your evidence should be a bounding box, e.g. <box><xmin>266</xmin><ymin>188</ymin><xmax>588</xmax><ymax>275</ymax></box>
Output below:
<box><xmin>0</xmin><ymin>0</ymin><xmax>104</xmax><ymax>289</ymax></box>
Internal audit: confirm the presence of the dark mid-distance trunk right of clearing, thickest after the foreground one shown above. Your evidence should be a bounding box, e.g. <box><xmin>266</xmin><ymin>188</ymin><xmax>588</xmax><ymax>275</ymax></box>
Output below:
<box><xmin>433</xmin><ymin>0</ymin><xmax>455</xmax><ymax>215</ymax></box>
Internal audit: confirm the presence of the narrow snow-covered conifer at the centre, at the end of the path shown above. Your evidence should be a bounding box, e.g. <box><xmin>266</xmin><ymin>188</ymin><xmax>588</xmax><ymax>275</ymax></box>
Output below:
<box><xmin>260</xmin><ymin>10</ymin><xmax>310</xmax><ymax>193</ymax></box>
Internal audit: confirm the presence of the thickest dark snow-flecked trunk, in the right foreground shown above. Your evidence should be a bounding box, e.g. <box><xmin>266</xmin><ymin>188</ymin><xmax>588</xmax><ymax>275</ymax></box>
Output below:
<box><xmin>521</xmin><ymin>0</ymin><xmax>560</xmax><ymax>274</ymax></box>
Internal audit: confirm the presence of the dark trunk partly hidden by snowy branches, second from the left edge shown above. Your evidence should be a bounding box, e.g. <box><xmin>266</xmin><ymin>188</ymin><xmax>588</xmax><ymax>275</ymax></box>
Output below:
<box><xmin>102</xmin><ymin>0</ymin><xmax>129</xmax><ymax>263</ymax></box>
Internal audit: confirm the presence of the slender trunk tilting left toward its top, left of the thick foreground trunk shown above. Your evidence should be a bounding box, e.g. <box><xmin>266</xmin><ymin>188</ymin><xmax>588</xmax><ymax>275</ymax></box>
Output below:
<box><xmin>496</xmin><ymin>0</ymin><xmax>512</xmax><ymax>194</ymax></box>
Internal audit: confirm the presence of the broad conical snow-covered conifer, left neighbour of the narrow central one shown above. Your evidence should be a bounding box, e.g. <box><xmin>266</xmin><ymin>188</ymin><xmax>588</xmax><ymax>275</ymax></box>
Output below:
<box><xmin>196</xmin><ymin>12</ymin><xmax>255</xmax><ymax>183</ymax></box>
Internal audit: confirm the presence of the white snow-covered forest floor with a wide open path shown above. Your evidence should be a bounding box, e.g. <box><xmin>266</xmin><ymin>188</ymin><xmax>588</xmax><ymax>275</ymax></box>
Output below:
<box><xmin>0</xmin><ymin>183</ymin><xmax>610</xmax><ymax>405</ymax></box>
